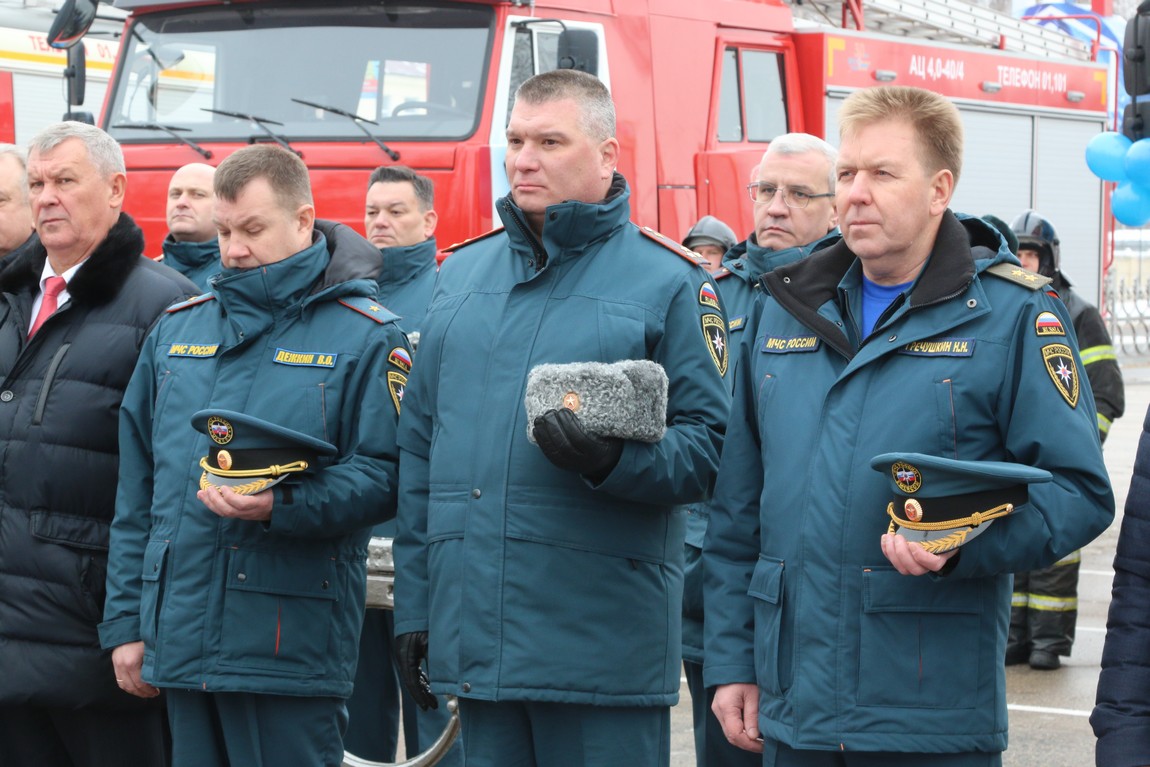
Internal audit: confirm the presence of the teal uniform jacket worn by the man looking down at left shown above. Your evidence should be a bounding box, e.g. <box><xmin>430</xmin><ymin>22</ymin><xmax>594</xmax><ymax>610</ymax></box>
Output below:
<box><xmin>100</xmin><ymin>227</ymin><xmax>409</xmax><ymax>697</ymax></box>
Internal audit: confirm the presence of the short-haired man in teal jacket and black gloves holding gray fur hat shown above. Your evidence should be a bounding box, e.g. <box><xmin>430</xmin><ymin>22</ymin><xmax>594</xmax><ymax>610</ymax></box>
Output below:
<box><xmin>396</xmin><ymin>69</ymin><xmax>729</xmax><ymax>767</ymax></box>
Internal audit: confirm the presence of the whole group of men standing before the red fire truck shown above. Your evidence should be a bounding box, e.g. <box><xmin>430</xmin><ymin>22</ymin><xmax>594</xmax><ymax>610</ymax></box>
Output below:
<box><xmin>0</xmin><ymin>70</ymin><xmax>1140</xmax><ymax>767</ymax></box>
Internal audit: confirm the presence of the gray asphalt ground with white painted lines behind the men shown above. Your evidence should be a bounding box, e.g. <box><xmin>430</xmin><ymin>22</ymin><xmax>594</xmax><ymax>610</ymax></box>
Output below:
<box><xmin>670</xmin><ymin>359</ymin><xmax>1150</xmax><ymax>767</ymax></box>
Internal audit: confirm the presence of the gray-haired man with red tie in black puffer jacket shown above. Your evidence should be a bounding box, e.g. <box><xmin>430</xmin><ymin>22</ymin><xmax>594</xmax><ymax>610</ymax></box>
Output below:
<box><xmin>0</xmin><ymin>122</ymin><xmax>196</xmax><ymax>767</ymax></box>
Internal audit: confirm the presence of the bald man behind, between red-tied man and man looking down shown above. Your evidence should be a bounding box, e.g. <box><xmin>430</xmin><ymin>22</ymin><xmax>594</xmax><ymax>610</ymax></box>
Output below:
<box><xmin>163</xmin><ymin>162</ymin><xmax>221</xmax><ymax>291</ymax></box>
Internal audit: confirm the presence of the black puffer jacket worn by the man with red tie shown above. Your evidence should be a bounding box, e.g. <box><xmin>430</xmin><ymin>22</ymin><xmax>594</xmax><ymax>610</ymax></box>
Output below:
<box><xmin>0</xmin><ymin>214</ymin><xmax>198</xmax><ymax>707</ymax></box>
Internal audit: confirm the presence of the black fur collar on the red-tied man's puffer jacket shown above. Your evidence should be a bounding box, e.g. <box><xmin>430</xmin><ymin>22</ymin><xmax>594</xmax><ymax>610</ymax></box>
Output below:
<box><xmin>0</xmin><ymin>213</ymin><xmax>144</xmax><ymax>306</ymax></box>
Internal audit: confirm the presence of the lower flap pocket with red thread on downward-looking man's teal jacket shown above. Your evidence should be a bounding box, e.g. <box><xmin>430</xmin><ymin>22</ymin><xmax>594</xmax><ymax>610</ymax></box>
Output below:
<box><xmin>220</xmin><ymin>551</ymin><xmax>339</xmax><ymax>675</ymax></box>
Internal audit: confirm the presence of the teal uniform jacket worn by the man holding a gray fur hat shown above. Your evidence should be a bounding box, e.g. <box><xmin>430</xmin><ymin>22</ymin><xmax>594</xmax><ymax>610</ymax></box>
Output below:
<box><xmin>396</xmin><ymin>176</ymin><xmax>729</xmax><ymax>706</ymax></box>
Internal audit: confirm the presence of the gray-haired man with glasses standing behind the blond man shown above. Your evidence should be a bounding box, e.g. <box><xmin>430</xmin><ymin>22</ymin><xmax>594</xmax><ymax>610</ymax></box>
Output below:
<box><xmin>683</xmin><ymin>133</ymin><xmax>838</xmax><ymax>767</ymax></box>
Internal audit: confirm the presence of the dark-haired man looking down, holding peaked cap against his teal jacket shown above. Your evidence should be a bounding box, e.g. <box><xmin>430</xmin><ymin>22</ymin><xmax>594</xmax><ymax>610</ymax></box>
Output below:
<box><xmin>100</xmin><ymin>145</ymin><xmax>411</xmax><ymax>767</ymax></box>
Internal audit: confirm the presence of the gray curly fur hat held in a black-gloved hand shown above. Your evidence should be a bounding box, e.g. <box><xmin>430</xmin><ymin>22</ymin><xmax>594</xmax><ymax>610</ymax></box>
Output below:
<box><xmin>524</xmin><ymin>360</ymin><xmax>667</xmax><ymax>443</ymax></box>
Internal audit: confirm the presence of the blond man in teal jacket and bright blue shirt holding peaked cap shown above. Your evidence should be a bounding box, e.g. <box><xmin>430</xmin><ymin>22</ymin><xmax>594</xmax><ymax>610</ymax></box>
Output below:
<box><xmin>704</xmin><ymin>86</ymin><xmax>1114</xmax><ymax>767</ymax></box>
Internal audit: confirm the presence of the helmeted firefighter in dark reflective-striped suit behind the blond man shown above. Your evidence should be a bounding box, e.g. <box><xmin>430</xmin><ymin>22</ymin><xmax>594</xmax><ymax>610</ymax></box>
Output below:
<box><xmin>1006</xmin><ymin>210</ymin><xmax>1126</xmax><ymax>670</ymax></box>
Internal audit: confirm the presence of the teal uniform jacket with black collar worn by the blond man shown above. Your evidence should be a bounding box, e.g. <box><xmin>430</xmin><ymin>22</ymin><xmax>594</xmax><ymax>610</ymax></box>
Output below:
<box><xmin>704</xmin><ymin>213</ymin><xmax>1113</xmax><ymax>752</ymax></box>
